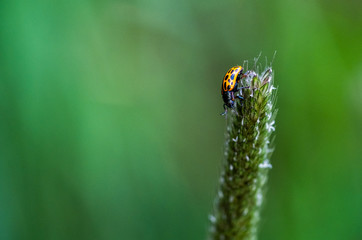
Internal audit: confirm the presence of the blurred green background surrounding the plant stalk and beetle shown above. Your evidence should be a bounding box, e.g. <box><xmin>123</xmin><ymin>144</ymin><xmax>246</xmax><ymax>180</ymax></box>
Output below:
<box><xmin>0</xmin><ymin>0</ymin><xmax>362</xmax><ymax>240</ymax></box>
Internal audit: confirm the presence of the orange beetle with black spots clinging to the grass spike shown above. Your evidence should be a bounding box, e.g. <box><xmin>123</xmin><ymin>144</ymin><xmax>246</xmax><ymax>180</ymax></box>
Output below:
<box><xmin>221</xmin><ymin>66</ymin><xmax>244</xmax><ymax>115</ymax></box>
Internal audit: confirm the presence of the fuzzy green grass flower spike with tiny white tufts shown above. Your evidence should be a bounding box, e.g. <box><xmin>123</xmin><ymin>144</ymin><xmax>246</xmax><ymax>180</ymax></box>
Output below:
<box><xmin>210</xmin><ymin>68</ymin><xmax>276</xmax><ymax>240</ymax></box>
